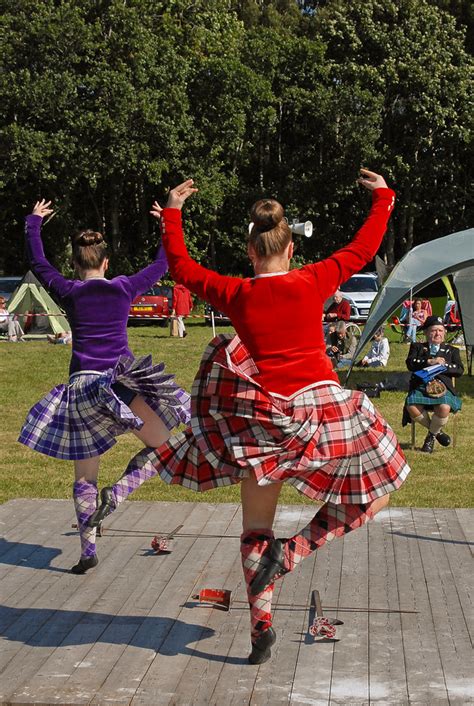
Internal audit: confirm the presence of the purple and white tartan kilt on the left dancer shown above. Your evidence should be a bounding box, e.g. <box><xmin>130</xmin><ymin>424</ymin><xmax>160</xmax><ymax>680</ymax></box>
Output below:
<box><xmin>18</xmin><ymin>356</ymin><xmax>190</xmax><ymax>461</ymax></box>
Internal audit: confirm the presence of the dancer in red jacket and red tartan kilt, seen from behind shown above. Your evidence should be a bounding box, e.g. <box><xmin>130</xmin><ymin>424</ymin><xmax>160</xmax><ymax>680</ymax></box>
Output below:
<box><xmin>95</xmin><ymin>169</ymin><xmax>409</xmax><ymax>664</ymax></box>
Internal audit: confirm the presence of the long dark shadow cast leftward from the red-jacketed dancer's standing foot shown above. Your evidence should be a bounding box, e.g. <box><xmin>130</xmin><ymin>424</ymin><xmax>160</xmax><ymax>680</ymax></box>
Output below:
<box><xmin>0</xmin><ymin>605</ymin><xmax>247</xmax><ymax>664</ymax></box>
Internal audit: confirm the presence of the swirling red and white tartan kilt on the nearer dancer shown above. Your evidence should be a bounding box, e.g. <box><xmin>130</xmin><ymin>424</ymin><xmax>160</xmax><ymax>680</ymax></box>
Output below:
<box><xmin>141</xmin><ymin>335</ymin><xmax>410</xmax><ymax>504</ymax></box>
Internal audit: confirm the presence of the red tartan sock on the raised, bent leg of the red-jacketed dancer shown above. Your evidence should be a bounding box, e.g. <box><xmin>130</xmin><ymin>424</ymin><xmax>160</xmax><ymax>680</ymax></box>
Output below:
<box><xmin>283</xmin><ymin>503</ymin><xmax>373</xmax><ymax>571</ymax></box>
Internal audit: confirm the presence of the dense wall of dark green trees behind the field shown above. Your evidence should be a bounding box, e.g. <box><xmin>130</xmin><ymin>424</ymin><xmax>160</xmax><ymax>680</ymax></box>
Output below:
<box><xmin>0</xmin><ymin>0</ymin><xmax>474</xmax><ymax>274</ymax></box>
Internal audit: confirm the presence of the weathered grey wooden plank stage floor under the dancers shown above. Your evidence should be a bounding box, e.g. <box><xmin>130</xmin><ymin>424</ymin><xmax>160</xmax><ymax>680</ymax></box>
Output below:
<box><xmin>0</xmin><ymin>500</ymin><xmax>474</xmax><ymax>706</ymax></box>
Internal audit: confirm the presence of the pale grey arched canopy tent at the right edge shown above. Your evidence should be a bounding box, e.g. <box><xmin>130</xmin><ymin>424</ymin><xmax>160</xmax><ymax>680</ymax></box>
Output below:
<box><xmin>347</xmin><ymin>228</ymin><xmax>474</xmax><ymax>377</ymax></box>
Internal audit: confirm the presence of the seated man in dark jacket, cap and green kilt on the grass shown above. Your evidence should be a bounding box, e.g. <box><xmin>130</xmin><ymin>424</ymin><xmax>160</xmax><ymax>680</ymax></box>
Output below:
<box><xmin>403</xmin><ymin>316</ymin><xmax>464</xmax><ymax>453</ymax></box>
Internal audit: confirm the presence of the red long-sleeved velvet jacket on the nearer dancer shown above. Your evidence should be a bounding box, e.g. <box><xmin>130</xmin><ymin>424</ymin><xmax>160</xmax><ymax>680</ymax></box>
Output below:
<box><xmin>161</xmin><ymin>189</ymin><xmax>395</xmax><ymax>397</ymax></box>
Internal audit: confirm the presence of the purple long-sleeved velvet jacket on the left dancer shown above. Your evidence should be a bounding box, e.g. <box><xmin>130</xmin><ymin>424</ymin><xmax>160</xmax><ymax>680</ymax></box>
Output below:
<box><xmin>26</xmin><ymin>214</ymin><xmax>168</xmax><ymax>373</ymax></box>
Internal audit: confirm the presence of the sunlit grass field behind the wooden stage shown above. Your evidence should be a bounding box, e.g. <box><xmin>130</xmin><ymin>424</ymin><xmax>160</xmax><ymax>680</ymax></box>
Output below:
<box><xmin>0</xmin><ymin>320</ymin><xmax>474</xmax><ymax>507</ymax></box>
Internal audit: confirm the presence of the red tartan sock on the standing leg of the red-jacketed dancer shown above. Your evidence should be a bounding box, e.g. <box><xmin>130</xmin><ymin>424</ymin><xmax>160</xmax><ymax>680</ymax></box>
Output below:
<box><xmin>240</xmin><ymin>529</ymin><xmax>274</xmax><ymax>641</ymax></box>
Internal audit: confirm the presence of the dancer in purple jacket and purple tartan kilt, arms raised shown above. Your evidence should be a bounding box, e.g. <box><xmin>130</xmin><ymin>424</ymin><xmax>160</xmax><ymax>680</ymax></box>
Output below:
<box><xmin>19</xmin><ymin>199</ymin><xmax>189</xmax><ymax>574</ymax></box>
